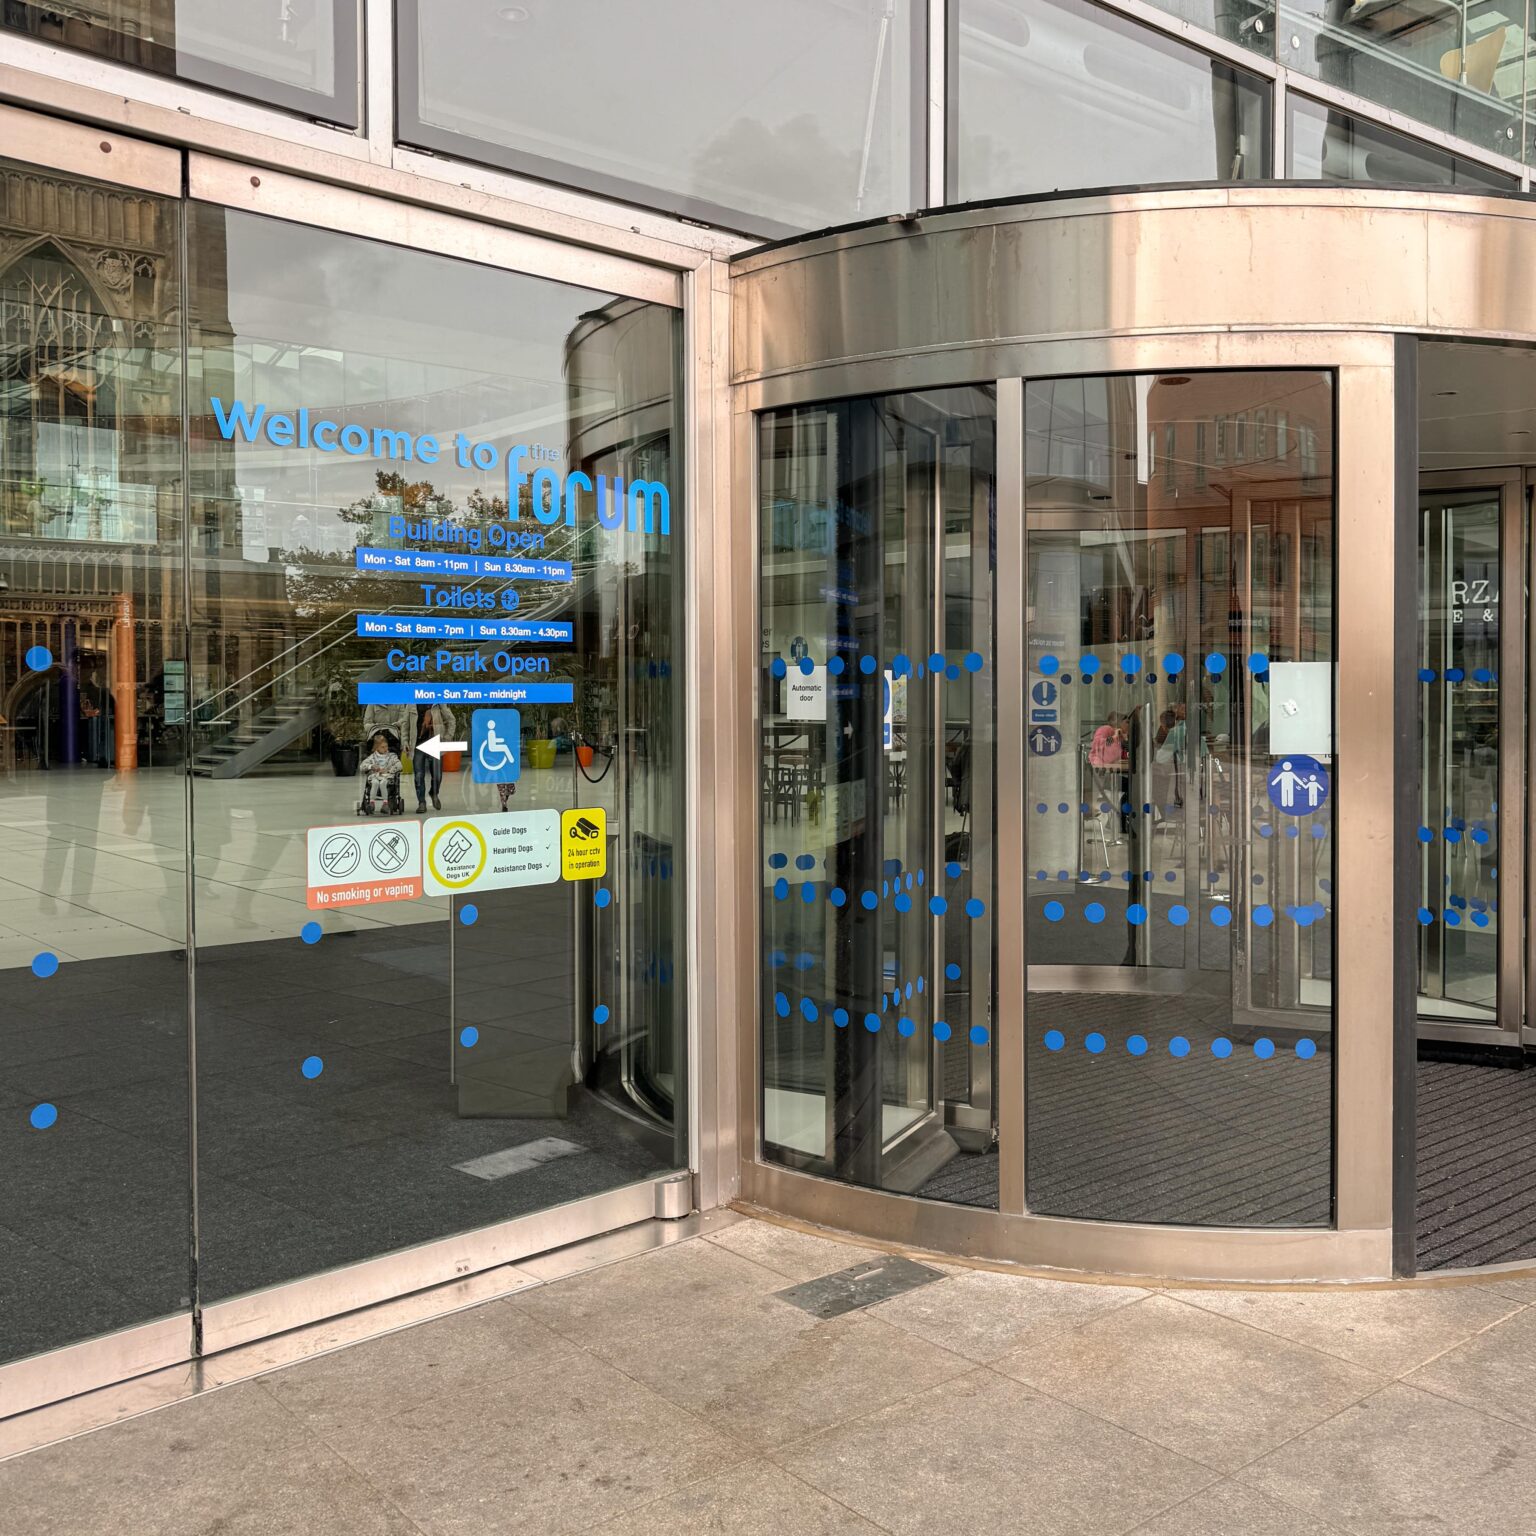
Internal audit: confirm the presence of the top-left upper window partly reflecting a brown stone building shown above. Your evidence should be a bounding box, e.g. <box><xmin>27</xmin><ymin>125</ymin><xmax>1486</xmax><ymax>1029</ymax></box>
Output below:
<box><xmin>0</xmin><ymin>0</ymin><xmax>358</xmax><ymax>127</ymax></box>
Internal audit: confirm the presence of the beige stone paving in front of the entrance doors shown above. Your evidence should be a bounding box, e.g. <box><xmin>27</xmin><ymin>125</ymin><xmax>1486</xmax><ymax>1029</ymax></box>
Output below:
<box><xmin>9</xmin><ymin>1221</ymin><xmax>1536</xmax><ymax>1536</ymax></box>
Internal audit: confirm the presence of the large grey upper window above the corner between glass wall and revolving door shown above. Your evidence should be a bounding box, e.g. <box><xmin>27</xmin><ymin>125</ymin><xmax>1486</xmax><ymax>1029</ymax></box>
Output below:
<box><xmin>399</xmin><ymin>0</ymin><xmax>926</xmax><ymax>233</ymax></box>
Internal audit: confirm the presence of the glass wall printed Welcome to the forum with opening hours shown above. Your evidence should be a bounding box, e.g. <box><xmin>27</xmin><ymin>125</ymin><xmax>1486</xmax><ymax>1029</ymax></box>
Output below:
<box><xmin>0</xmin><ymin>164</ymin><xmax>688</xmax><ymax>1359</ymax></box>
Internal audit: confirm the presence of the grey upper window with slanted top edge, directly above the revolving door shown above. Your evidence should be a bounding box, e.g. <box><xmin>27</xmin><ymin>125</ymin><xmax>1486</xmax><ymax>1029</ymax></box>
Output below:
<box><xmin>957</xmin><ymin>0</ymin><xmax>1270</xmax><ymax>201</ymax></box>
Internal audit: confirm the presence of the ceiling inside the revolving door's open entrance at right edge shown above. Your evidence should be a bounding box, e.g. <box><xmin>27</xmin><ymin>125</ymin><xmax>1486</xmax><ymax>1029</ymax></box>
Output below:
<box><xmin>1419</xmin><ymin>341</ymin><xmax>1536</xmax><ymax>470</ymax></box>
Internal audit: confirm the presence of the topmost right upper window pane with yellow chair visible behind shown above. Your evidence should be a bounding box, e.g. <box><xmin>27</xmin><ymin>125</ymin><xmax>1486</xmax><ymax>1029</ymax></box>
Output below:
<box><xmin>1276</xmin><ymin>0</ymin><xmax>1527</xmax><ymax>160</ymax></box>
